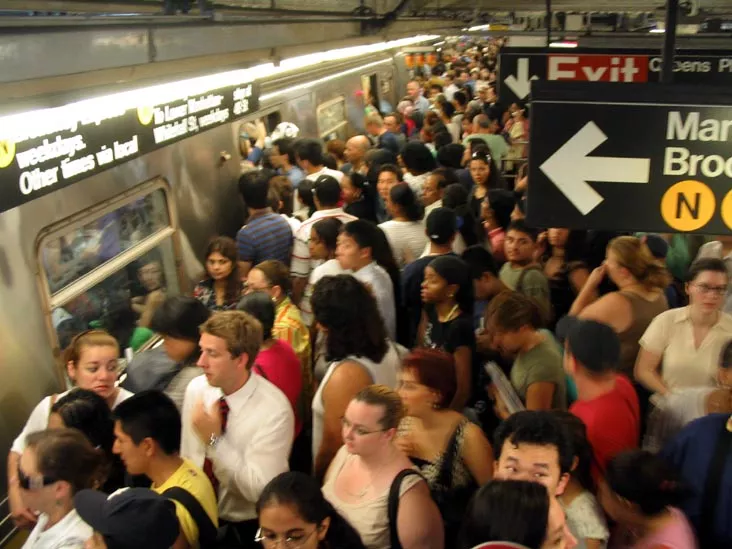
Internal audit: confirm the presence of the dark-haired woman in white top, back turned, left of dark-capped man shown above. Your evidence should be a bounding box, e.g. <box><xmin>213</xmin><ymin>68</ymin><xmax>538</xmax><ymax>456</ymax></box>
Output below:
<box><xmin>379</xmin><ymin>183</ymin><xmax>427</xmax><ymax>269</ymax></box>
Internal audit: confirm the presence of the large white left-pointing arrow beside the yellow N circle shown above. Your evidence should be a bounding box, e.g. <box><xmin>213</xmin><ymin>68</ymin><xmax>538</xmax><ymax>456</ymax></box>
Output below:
<box><xmin>539</xmin><ymin>122</ymin><xmax>651</xmax><ymax>215</ymax></box>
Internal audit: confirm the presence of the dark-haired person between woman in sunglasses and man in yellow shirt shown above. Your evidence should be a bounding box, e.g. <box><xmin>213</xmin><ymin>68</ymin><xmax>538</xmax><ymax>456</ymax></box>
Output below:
<box><xmin>48</xmin><ymin>389</ymin><xmax>125</xmax><ymax>494</ymax></box>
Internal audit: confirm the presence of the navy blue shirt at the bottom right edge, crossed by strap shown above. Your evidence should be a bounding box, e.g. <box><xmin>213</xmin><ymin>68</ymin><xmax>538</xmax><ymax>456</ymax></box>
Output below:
<box><xmin>660</xmin><ymin>414</ymin><xmax>732</xmax><ymax>549</ymax></box>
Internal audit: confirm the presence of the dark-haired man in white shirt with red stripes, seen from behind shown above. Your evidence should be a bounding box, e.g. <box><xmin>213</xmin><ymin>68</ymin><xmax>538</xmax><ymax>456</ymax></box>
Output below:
<box><xmin>290</xmin><ymin>175</ymin><xmax>356</xmax><ymax>303</ymax></box>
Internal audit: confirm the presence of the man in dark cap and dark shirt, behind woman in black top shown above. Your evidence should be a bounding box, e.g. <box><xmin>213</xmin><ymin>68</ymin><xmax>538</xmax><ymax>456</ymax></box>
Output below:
<box><xmin>402</xmin><ymin>208</ymin><xmax>457</xmax><ymax>347</ymax></box>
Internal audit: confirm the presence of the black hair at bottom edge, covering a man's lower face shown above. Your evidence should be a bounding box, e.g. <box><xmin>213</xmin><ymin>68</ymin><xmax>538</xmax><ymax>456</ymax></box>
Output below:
<box><xmin>458</xmin><ymin>480</ymin><xmax>549</xmax><ymax>549</ymax></box>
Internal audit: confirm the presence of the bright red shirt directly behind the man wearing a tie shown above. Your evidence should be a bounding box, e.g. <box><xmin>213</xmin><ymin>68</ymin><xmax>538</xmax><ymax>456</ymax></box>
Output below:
<box><xmin>253</xmin><ymin>339</ymin><xmax>302</xmax><ymax>437</ymax></box>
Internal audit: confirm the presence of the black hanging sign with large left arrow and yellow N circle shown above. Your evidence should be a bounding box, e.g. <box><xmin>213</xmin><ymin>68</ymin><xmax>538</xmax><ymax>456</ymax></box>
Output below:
<box><xmin>527</xmin><ymin>81</ymin><xmax>732</xmax><ymax>234</ymax></box>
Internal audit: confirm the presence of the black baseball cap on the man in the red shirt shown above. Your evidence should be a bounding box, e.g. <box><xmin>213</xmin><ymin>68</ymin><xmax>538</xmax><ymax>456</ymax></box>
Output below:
<box><xmin>557</xmin><ymin>315</ymin><xmax>620</xmax><ymax>374</ymax></box>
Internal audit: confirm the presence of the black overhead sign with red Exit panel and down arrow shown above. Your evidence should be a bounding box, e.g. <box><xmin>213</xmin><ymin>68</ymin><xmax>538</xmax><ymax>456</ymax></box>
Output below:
<box><xmin>498</xmin><ymin>48</ymin><xmax>732</xmax><ymax>105</ymax></box>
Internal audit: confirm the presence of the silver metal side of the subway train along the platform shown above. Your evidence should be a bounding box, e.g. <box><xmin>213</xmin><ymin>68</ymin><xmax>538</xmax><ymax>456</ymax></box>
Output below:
<box><xmin>0</xmin><ymin>52</ymin><xmax>407</xmax><ymax>539</ymax></box>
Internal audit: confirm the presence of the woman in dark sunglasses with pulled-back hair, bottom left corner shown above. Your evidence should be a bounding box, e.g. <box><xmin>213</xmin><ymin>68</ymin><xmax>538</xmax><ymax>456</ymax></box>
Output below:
<box><xmin>16</xmin><ymin>429</ymin><xmax>104</xmax><ymax>549</ymax></box>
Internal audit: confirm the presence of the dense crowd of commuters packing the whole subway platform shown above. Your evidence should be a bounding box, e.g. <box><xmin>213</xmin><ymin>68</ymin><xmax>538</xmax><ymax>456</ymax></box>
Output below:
<box><xmin>8</xmin><ymin>38</ymin><xmax>732</xmax><ymax>549</ymax></box>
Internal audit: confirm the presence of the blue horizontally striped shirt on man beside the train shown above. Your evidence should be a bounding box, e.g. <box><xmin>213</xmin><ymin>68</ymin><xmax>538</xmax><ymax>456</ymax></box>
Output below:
<box><xmin>236</xmin><ymin>210</ymin><xmax>292</xmax><ymax>266</ymax></box>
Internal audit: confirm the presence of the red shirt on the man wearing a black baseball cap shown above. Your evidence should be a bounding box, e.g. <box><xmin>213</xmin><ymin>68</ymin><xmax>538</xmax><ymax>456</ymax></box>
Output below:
<box><xmin>569</xmin><ymin>374</ymin><xmax>640</xmax><ymax>476</ymax></box>
